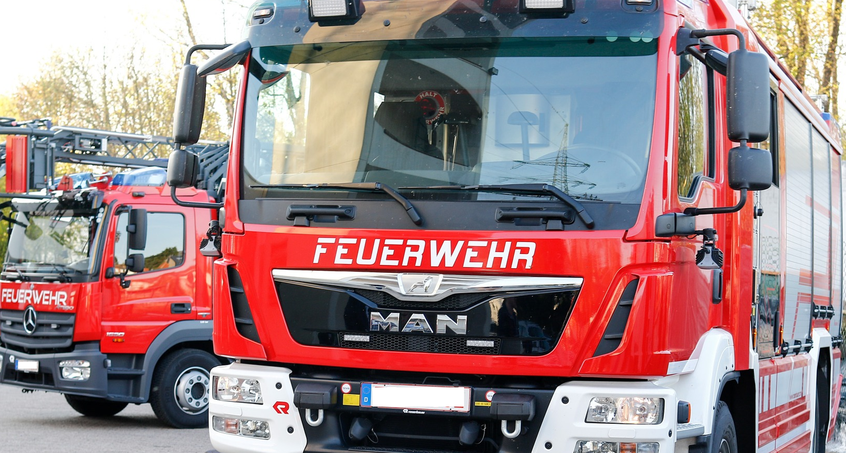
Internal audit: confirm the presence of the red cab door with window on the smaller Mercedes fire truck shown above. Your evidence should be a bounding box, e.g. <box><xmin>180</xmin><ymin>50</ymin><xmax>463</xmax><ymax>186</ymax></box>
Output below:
<box><xmin>101</xmin><ymin>206</ymin><xmax>196</xmax><ymax>354</ymax></box>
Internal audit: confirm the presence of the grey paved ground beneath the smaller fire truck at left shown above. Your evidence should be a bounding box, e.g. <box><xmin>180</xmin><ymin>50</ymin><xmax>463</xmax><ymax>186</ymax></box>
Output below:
<box><xmin>0</xmin><ymin>385</ymin><xmax>213</xmax><ymax>453</ymax></box>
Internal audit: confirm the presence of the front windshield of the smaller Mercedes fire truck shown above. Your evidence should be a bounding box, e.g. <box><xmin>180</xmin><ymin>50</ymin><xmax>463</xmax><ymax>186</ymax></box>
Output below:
<box><xmin>3</xmin><ymin>208</ymin><xmax>104</xmax><ymax>281</ymax></box>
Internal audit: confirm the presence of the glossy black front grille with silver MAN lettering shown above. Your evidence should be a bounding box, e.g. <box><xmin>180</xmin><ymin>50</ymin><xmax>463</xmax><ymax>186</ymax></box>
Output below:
<box><xmin>276</xmin><ymin>280</ymin><xmax>579</xmax><ymax>356</ymax></box>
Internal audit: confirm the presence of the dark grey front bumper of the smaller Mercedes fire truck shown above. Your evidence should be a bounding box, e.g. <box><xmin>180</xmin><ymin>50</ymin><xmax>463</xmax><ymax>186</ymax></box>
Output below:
<box><xmin>0</xmin><ymin>343</ymin><xmax>108</xmax><ymax>398</ymax></box>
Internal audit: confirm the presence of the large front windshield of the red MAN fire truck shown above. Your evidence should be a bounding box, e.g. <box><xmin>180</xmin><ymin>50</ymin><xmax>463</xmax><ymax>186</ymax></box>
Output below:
<box><xmin>242</xmin><ymin>37</ymin><xmax>657</xmax><ymax>203</ymax></box>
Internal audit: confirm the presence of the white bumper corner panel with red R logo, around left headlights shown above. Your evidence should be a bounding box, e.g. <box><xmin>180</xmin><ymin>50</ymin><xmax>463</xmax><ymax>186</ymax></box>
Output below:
<box><xmin>209</xmin><ymin>363</ymin><xmax>306</xmax><ymax>453</ymax></box>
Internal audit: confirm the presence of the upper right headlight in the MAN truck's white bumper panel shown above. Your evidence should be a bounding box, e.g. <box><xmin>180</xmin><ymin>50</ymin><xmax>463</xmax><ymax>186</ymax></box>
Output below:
<box><xmin>585</xmin><ymin>397</ymin><xmax>664</xmax><ymax>425</ymax></box>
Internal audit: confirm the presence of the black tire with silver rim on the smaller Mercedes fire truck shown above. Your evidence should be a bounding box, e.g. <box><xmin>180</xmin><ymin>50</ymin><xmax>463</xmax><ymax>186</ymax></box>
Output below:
<box><xmin>150</xmin><ymin>349</ymin><xmax>220</xmax><ymax>428</ymax></box>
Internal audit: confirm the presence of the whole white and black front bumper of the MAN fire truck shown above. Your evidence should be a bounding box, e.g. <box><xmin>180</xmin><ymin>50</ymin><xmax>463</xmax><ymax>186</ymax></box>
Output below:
<box><xmin>209</xmin><ymin>363</ymin><xmax>679</xmax><ymax>453</ymax></box>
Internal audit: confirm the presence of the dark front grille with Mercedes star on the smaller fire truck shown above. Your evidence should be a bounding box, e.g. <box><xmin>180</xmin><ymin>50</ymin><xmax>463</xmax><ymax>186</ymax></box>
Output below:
<box><xmin>0</xmin><ymin>310</ymin><xmax>75</xmax><ymax>353</ymax></box>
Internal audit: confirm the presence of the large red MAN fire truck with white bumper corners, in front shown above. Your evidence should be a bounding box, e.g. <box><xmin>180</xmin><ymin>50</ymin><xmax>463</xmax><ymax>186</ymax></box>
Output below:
<box><xmin>168</xmin><ymin>0</ymin><xmax>843</xmax><ymax>453</ymax></box>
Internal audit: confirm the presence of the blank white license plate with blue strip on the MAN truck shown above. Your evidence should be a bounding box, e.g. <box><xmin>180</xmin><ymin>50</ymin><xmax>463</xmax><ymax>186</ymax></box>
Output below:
<box><xmin>361</xmin><ymin>382</ymin><xmax>470</xmax><ymax>412</ymax></box>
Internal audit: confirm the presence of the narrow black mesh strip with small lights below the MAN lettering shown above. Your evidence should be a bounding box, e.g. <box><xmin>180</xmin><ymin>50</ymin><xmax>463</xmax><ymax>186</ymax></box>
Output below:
<box><xmin>339</xmin><ymin>333</ymin><xmax>502</xmax><ymax>355</ymax></box>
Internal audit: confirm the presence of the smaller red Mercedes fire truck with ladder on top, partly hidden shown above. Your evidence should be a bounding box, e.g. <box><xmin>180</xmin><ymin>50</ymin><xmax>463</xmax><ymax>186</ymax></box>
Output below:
<box><xmin>0</xmin><ymin>125</ymin><xmax>227</xmax><ymax>428</ymax></box>
